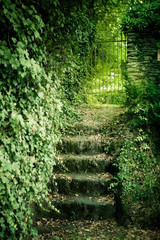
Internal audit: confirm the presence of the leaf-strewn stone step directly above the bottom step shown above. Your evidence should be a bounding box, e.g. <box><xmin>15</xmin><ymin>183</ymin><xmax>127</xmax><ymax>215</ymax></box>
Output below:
<box><xmin>51</xmin><ymin>173</ymin><xmax>113</xmax><ymax>196</ymax></box>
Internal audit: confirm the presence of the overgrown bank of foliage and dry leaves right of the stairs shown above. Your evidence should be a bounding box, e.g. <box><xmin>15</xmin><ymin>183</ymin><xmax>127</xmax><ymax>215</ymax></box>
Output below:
<box><xmin>105</xmin><ymin>119</ymin><xmax>160</xmax><ymax>225</ymax></box>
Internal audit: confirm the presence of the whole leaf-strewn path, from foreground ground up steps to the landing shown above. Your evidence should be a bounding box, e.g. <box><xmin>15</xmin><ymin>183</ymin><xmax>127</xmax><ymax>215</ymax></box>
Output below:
<box><xmin>37</xmin><ymin>105</ymin><xmax>159</xmax><ymax>240</ymax></box>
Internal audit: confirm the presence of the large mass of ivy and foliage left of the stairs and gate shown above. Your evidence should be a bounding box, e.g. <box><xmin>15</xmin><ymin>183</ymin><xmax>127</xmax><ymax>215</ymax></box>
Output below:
<box><xmin>0</xmin><ymin>0</ymin><xmax>112</xmax><ymax>240</ymax></box>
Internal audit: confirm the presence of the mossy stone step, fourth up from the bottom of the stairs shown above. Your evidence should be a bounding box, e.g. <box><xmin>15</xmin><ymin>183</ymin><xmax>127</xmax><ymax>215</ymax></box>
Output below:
<box><xmin>59</xmin><ymin>135</ymin><xmax>104</xmax><ymax>154</ymax></box>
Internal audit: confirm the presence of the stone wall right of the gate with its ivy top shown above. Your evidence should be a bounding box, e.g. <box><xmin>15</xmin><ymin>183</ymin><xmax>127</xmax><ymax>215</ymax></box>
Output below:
<box><xmin>122</xmin><ymin>0</ymin><xmax>160</xmax><ymax>83</ymax></box>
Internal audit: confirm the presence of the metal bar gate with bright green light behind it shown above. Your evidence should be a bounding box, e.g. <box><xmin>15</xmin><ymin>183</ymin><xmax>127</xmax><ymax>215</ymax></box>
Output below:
<box><xmin>86</xmin><ymin>31</ymin><xmax>127</xmax><ymax>103</ymax></box>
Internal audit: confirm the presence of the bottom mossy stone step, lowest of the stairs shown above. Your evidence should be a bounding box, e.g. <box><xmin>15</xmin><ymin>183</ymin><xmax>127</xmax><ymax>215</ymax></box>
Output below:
<box><xmin>35</xmin><ymin>195</ymin><xmax>115</xmax><ymax>220</ymax></box>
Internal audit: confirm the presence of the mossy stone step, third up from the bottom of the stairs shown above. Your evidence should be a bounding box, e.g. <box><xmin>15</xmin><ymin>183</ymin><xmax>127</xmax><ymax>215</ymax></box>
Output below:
<box><xmin>54</xmin><ymin>153</ymin><xmax>112</xmax><ymax>173</ymax></box>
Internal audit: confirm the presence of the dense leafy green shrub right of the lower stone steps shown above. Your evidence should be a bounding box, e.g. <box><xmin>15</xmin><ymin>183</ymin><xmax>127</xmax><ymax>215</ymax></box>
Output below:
<box><xmin>115</xmin><ymin>129</ymin><xmax>160</xmax><ymax>226</ymax></box>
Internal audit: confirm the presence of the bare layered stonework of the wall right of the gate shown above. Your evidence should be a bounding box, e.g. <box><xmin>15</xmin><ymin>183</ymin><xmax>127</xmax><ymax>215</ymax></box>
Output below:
<box><xmin>127</xmin><ymin>31</ymin><xmax>160</xmax><ymax>81</ymax></box>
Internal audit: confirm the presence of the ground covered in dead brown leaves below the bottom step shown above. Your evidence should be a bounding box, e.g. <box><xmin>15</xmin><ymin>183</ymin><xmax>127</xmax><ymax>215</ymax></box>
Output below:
<box><xmin>37</xmin><ymin>219</ymin><xmax>160</xmax><ymax>240</ymax></box>
